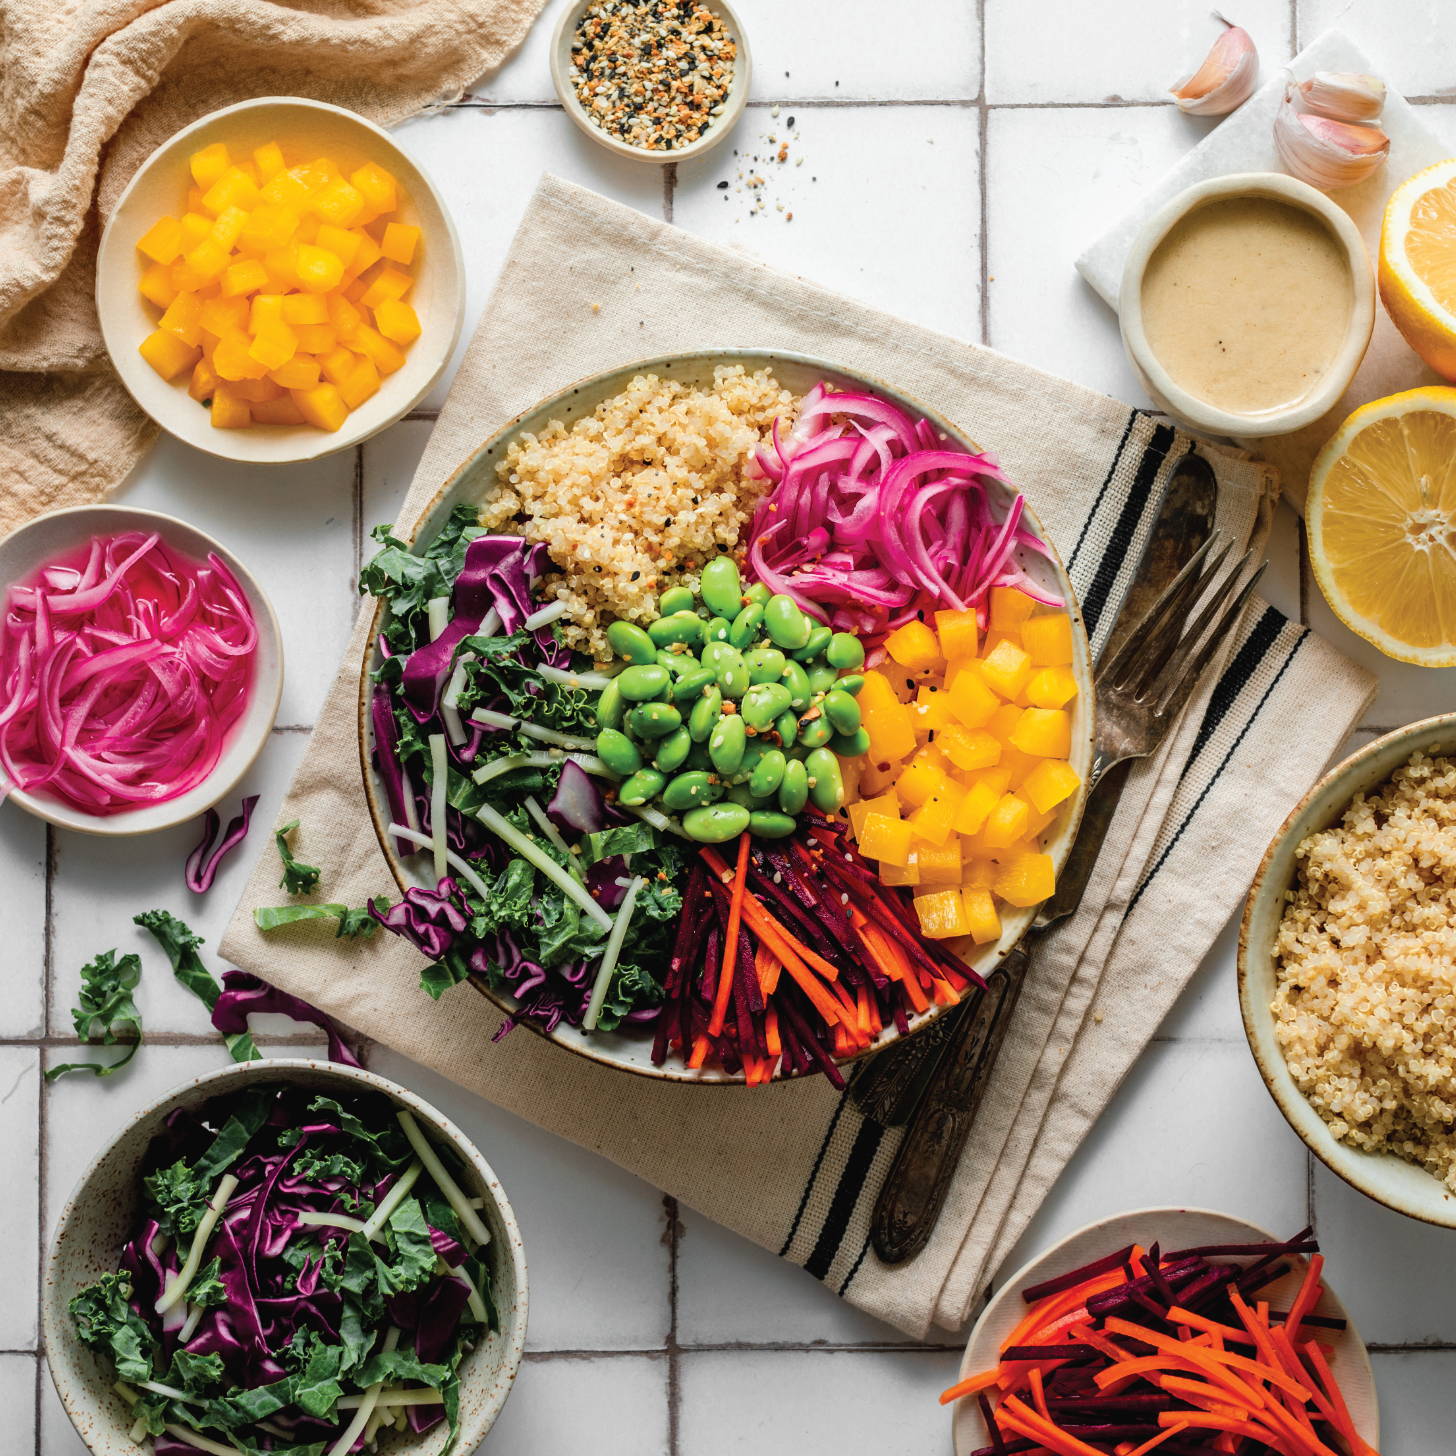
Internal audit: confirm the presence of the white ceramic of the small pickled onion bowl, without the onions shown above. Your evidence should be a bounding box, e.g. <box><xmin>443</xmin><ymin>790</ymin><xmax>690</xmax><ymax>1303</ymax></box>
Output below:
<box><xmin>0</xmin><ymin>504</ymin><xmax>282</xmax><ymax>836</ymax></box>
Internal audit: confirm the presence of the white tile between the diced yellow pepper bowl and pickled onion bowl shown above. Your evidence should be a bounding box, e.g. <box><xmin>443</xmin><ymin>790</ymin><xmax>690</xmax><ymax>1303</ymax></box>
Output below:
<box><xmin>118</xmin><ymin>435</ymin><xmax>354</xmax><ymax>724</ymax></box>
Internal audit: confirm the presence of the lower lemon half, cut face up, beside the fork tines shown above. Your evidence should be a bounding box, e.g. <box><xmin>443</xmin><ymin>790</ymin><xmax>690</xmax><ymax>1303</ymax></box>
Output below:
<box><xmin>1305</xmin><ymin>386</ymin><xmax>1456</xmax><ymax>667</ymax></box>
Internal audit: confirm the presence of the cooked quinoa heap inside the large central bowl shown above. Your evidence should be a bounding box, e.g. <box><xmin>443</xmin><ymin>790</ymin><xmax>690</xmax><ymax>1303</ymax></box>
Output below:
<box><xmin>480</xmin><ymin>364</ymin><xmax>795</xmax><ymax>660</ymax></box>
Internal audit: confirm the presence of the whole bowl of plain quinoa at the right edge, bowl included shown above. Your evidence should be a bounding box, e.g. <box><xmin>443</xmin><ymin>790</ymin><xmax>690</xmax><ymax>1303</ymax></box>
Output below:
<box><xmin>1239</xmin><ymin>715</ymin><xmax>1456</xmax><ymax>1227</ymax></box>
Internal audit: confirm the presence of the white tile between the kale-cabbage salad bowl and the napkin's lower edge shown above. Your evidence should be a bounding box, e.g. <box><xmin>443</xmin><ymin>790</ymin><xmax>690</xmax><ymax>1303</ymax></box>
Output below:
<box><xmin>368</xmin><ymin>1045</ymin><xmax>670</xmax><ymax>1350</ymax></box>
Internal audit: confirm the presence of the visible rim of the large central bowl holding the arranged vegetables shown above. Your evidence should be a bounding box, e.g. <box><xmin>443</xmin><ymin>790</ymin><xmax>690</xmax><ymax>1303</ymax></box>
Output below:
<box><xmin>358</xmin><ymin>348</ymin><xmax>1096</xmax><ymax>1086</ymax></box>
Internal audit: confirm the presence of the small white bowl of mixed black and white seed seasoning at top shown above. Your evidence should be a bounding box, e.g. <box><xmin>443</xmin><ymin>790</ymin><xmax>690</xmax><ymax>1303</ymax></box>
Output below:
<box><xmin>550</xmin><ymin>0</ymin><xmax>751</xmax><ymax>163</ymax></box>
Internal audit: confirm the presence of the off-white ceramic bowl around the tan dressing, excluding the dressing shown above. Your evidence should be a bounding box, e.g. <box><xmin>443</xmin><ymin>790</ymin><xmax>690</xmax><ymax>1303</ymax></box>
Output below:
<box><xmin>1117</xmin><ymin>172</ymin><xmax>1374</xmax><ymax>435</ymax></box>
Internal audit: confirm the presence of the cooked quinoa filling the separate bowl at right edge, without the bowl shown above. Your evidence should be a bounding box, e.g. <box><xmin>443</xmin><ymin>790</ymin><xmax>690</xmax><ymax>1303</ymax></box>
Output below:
<box><xmin>1274</xmin><ymin>753</ymin><xmax>1456</xmax><ymax>1191</ymax></box>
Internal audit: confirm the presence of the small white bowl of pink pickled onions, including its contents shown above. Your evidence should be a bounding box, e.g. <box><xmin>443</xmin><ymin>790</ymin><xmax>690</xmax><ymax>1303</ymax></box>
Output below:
<box><xmin>0</xmin><ymin>505</ymin><xmax>282</xmax><ymax>834</ymax></box>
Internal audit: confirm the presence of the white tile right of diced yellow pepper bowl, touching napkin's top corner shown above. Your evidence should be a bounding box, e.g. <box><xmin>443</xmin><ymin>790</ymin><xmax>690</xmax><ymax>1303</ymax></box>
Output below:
<box><xmin>395</xmin><ymin>106</ymin><xmax>664</xmax><ymax>408</ymax></box>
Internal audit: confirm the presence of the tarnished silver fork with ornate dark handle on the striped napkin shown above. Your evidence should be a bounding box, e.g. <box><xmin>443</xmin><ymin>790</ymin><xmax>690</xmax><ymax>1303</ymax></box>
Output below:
<box><xmin>860</xmin><ymin>536</ymin><xmax>1264</xmax><ymax>1264</ymax></box>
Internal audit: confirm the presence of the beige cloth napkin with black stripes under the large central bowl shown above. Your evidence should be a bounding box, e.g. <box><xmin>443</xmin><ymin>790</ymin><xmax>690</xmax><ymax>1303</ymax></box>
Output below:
<box><xmin>221</xmin><ymin>178</ymin><xmax>1370</xmax><ymax>1337</ymax></box>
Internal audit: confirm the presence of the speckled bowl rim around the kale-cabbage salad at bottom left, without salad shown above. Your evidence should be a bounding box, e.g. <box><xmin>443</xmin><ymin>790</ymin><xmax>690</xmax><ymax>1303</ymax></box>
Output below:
<box><xmin>41</xmin><ymin>1057</ymin><xmax>527</xmax><ymax>1456</ymax></box>
